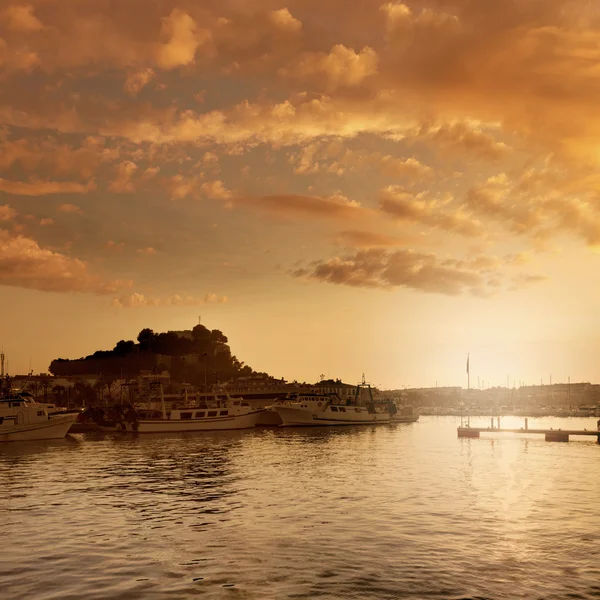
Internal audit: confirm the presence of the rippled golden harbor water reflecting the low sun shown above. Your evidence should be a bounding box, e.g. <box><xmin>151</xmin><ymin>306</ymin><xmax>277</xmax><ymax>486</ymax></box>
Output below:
<box><xmin>0</xmin><ymin>417</ymin><xmax>600</xmax><ymax>600</ymax></box>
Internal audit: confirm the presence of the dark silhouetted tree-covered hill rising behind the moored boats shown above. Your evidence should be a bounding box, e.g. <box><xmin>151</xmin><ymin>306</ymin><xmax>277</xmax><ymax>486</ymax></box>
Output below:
<box><xmin>48</xmin><ymin>325</ymin><xmax>262</xmax><ymax>385</ymax></box>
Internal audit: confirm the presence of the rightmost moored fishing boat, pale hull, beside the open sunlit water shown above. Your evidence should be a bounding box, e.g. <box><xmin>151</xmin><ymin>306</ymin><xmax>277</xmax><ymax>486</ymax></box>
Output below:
<box><xmin>272</xmin><ymin>376</ymin><xmax>397</xmax><ymax>427</ymax></box>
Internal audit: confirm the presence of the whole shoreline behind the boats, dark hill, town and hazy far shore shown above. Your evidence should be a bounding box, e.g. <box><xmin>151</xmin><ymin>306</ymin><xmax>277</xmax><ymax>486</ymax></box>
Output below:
<box><xmin>0</xmin><ymin>323</ymin><xmax>600</xmax><ymax>417</ymax></box>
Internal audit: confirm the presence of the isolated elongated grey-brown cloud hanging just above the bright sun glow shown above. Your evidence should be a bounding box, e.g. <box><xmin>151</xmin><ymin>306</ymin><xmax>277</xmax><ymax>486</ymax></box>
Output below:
<box><xmin>293</xmin><ymin>249</ymin><xmax>492</xmax><ymax>295</ymax></box>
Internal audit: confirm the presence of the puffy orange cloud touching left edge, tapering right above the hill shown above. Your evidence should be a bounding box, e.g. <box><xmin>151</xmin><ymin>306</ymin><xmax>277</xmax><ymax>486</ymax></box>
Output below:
<box><xmin>0</xmin><ymin>231</ymin><xmax>131</xmax><ymax>294</ymax></box>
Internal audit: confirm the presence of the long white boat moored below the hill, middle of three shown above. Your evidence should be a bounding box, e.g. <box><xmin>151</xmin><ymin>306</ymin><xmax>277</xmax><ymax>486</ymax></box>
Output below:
<box><xmin>125</xmin><ymin>389</ymin><xmax>264</xmax><ymax>433</ymax></box>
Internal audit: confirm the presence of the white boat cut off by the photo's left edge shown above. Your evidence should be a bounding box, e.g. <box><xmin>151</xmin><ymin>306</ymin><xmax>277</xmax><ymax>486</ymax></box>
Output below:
<box><xmin>0</xmin><ymin>396</ymin><xmax>79</xmax><ymax>442</ymax></box>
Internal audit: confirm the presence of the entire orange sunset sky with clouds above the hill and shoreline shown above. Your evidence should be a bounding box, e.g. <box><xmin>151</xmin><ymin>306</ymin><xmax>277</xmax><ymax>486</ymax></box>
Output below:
<box><xmin>0</xmin><ymin>0</ymin><xmax>600</xmax><ymax>388</ymax></box>
